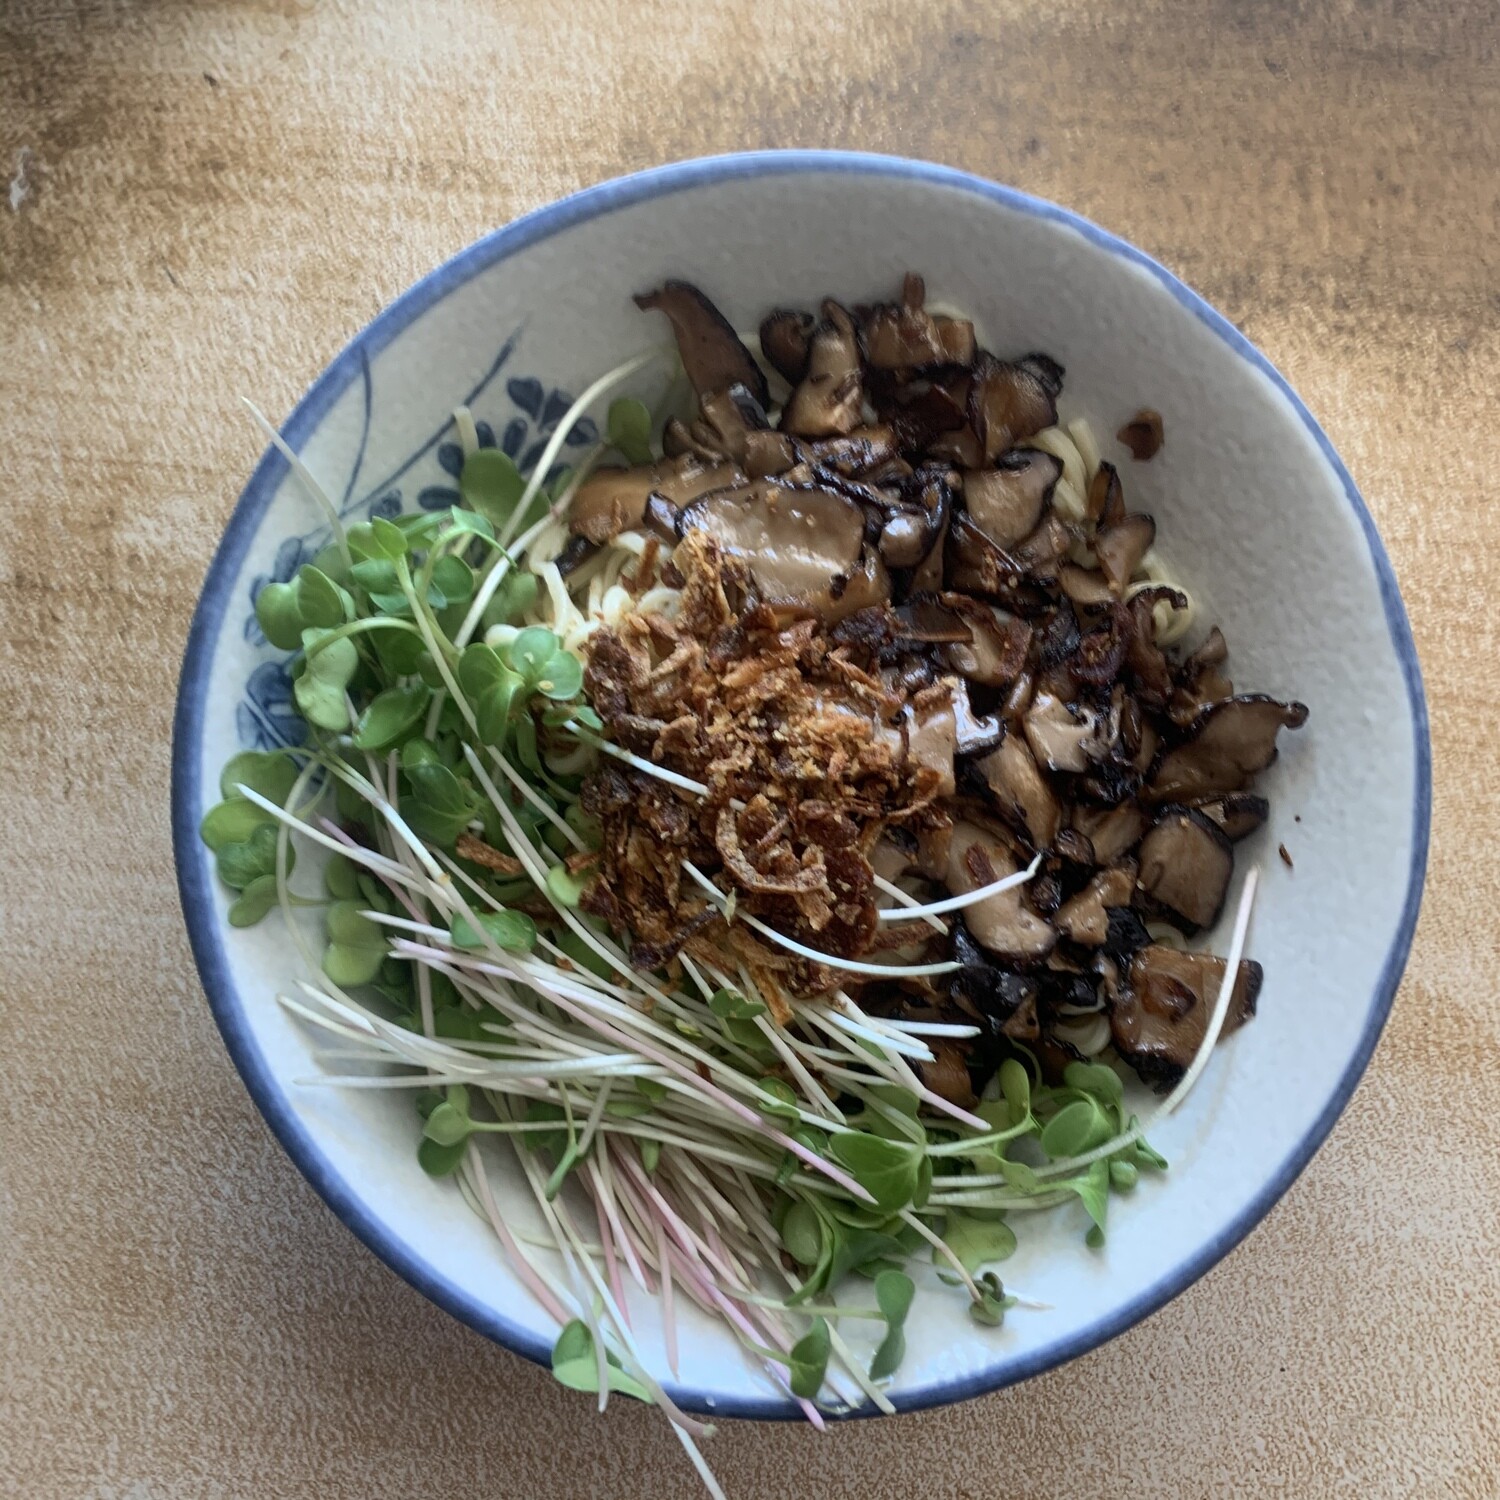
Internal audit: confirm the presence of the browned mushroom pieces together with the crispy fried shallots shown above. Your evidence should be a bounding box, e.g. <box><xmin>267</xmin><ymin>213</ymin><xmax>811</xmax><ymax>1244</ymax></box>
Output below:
<box><xmin>564</xmin><ymin>276</ymin><xmax>1307</xmax><ymax>1103</ymax></box>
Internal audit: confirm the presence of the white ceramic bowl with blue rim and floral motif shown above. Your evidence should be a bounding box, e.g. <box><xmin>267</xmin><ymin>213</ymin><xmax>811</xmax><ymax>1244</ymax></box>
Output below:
<box><xmin>173</xmin><ymin>153</ymin><xmax>1430</xmax><ymax>1418</ymax></box>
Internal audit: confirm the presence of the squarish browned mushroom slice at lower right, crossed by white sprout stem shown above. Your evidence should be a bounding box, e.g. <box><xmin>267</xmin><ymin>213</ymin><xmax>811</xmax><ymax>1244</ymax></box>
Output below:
<box><xmin>1110</xmin><ymin>944</ymin><xmax>1263</xmax><ymax>1089</ymax></box>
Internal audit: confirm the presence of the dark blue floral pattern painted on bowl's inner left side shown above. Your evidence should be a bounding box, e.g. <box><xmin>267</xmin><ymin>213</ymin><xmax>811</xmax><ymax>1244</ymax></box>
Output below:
<box><xmin>234</xmin><ymin>329</ymin><xmax>599</xmax><ymax>750</ymax></box>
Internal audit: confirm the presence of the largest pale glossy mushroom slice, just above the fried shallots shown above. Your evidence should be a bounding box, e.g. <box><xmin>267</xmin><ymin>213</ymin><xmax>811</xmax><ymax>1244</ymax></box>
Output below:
<box><xmin>678</xmin><ymin>480</ymin><xmax>890</xmax><ymax>621</ymax></box>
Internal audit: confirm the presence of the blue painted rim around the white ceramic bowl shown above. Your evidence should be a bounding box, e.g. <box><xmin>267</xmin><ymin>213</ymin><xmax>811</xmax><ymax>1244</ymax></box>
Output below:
<box><xmin>173</xmin><ymin>152</ymin><xmax>1433</xmax><ymax>1421</ymax></box>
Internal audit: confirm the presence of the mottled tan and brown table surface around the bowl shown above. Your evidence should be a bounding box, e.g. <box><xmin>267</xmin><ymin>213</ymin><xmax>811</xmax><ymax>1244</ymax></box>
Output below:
<box><xmin>0</xmin><ymin>0</ymin><xmax>1500</xmax><ymax>1500</ymax></box>
